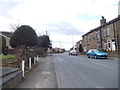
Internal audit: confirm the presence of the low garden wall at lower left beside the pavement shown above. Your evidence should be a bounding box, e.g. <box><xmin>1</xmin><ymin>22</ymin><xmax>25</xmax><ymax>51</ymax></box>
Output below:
<box><xmin>0</xmin><ymin>56</ymin><xmax>37</xmax><ymax>89</ymax></box>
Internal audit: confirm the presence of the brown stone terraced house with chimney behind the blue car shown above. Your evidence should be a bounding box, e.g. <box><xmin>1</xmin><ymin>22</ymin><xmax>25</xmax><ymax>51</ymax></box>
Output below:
<box><xmin>82</xmin><ymin>16</ymin><xmax>120</xmax><ymax>52</ymax></box>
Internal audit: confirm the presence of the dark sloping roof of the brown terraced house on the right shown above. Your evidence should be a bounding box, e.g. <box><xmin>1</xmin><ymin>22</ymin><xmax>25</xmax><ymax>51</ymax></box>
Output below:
<box><xmin>82</xmin><ymin>16</ymin><xmax>120</xmax><ymax>37</ymax></box>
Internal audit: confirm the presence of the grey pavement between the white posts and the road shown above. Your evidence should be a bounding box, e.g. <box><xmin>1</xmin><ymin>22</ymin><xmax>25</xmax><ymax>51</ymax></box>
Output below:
<box><xmin>16</xmin><ymin>56</ymin><xmax>58</xmax><ymax>88</ymax></box>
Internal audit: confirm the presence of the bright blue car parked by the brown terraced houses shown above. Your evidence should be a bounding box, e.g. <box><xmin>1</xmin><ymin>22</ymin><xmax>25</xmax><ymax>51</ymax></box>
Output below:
<box><xmin>87</xmin><ymin>49</ymin><xmax>108</xmax><ymax>59</ymax></box>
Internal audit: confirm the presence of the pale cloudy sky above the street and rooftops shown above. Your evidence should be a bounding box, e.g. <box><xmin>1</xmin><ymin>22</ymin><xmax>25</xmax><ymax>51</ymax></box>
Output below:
<box><xmin>0</xmin><ymin>0</ymin><xmax>119</xmax><ymax>50</ymax></box>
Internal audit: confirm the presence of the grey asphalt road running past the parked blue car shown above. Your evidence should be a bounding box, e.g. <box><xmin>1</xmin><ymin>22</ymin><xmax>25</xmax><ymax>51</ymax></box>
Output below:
<box><xmin>52</xmin><ymin>53</ymin><xmax>118</xmax><ymax>88</ymax></box>
